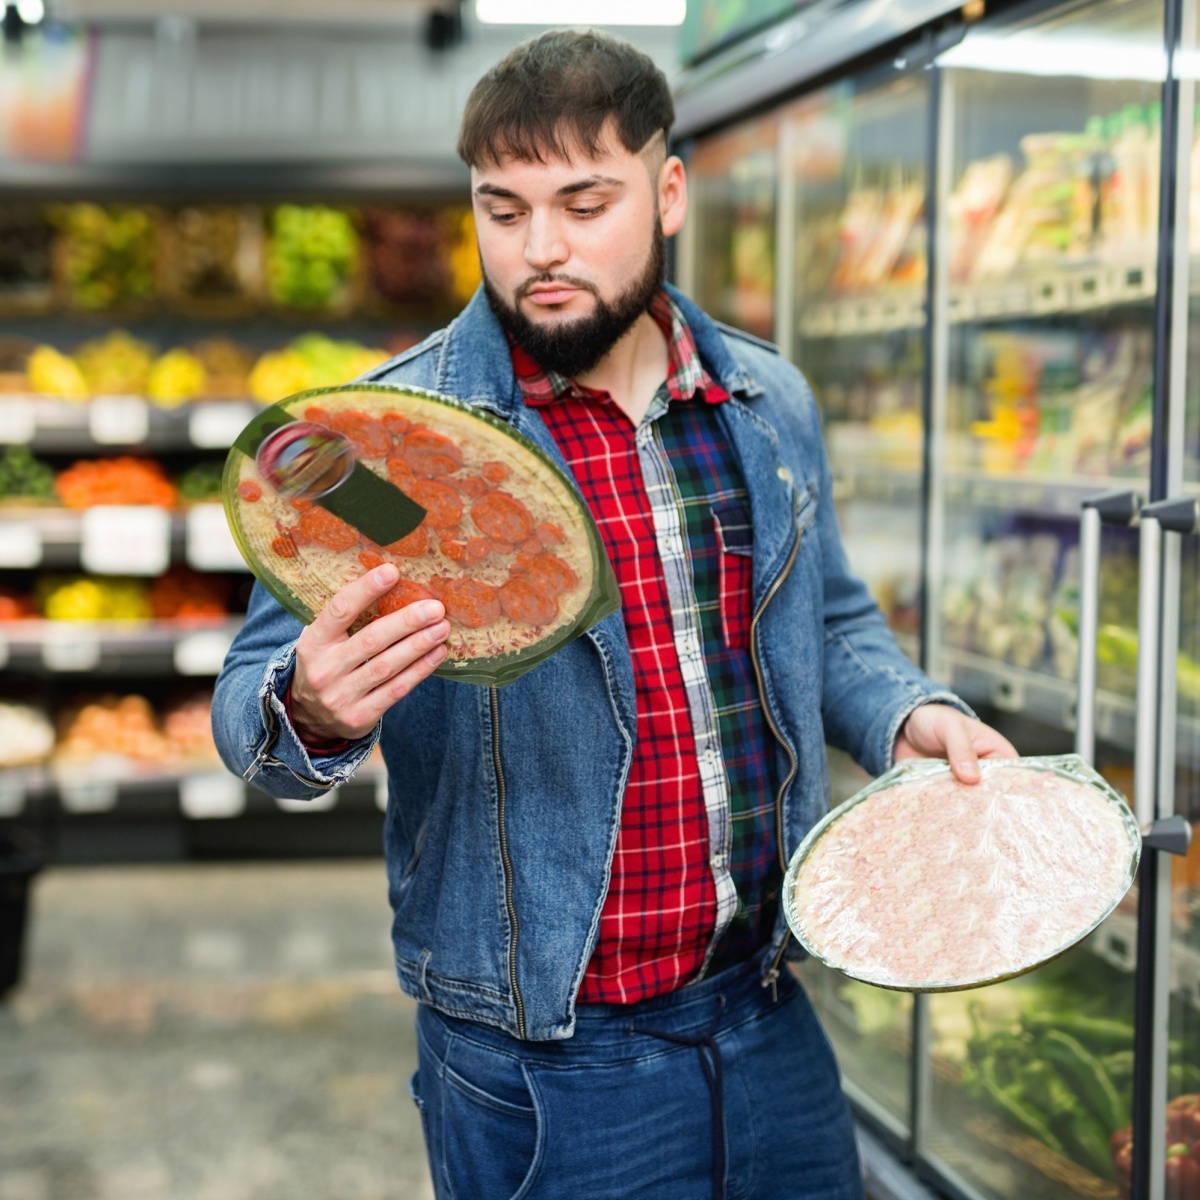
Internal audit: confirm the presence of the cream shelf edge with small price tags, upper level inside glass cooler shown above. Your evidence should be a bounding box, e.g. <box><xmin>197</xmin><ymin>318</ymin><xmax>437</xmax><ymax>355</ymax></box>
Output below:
<box><xmin>799</xmin><ymin>259</ymin><xmax>1154</xmax><ymax>337</ymax></box>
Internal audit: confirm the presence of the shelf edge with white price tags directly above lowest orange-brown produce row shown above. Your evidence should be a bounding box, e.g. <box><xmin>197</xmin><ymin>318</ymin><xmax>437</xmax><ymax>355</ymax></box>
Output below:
<box><xmin>0</xmin><ymin>619</ymin><xmax>241</xmax><ymax>678</ymax></box>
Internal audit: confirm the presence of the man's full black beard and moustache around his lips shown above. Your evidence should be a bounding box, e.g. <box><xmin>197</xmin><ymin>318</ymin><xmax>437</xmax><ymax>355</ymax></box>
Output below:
<box><xmin>484</xmin><ymin>221</ymin><xmax>666</xmax><ymax>379</ymax></box>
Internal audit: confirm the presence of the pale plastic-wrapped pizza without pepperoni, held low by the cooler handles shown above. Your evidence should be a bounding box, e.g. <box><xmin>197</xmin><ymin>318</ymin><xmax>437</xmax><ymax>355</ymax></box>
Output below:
<box><xmin>784</xmin><ymin>755</ymin><xmax>1141</xmax><ymax>991</ymax></box>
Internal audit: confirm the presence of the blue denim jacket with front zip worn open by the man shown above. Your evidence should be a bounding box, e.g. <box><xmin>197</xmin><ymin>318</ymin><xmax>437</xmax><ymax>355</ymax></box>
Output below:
<box><xmin>212</xmin><ymin>283</ymin><xmax>961</xmax><ymax>1039</ymax></box>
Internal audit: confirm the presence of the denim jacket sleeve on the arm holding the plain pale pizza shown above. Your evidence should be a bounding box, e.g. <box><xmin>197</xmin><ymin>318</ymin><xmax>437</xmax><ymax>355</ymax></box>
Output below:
<box><xmin>805</xmin><ymin>386</ymin><xmax>974</xmax><ymax>775</ymax></box>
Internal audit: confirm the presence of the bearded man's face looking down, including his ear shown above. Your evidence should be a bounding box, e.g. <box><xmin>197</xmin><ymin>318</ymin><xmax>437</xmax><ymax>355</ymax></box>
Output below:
<box><xmin>472</xmin><ymin>121</ymin><xmax>685</xmax><ymax>376</ymax></box>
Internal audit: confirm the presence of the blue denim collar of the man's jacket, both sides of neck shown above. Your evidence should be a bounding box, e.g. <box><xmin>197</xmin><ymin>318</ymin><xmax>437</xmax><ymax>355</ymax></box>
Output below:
<box><xmin>434</xmin><ymin>284</ymin><xmax>762</xmax><ymax>422</ymax></box>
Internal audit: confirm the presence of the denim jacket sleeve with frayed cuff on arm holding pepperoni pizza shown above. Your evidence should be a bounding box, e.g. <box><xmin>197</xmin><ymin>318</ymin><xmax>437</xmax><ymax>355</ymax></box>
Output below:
<box><xmin>212</xmin><ymin>583</ymin><xmax>379</xmax><ymax>799</ymax></box>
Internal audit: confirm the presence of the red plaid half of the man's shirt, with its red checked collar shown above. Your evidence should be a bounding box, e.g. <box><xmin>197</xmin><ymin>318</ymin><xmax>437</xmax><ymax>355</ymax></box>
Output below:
<box><xmin>512</xmin><ymin>292</ymin><xmax>728</xmax><ymax>1003</ymax></box>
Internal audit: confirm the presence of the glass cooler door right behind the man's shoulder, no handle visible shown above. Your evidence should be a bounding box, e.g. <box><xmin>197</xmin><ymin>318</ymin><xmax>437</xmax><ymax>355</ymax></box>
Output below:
<box><xmin>778</xmin><ymin>70</ymin><xmax>929</xmax><ymax>1140</ymax></box>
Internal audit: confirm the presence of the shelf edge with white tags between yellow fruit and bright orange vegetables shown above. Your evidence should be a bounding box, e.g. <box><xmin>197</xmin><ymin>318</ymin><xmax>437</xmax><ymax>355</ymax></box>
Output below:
<box><xmin>0</xmin><ymin>394</ymin><xmax>259</xmax><ymax>454</ymax></box>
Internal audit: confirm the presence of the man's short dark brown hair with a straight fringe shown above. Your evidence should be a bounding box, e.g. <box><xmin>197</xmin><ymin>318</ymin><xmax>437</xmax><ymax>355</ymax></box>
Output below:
<box><xmin>457</xmin><ymin>29</ymin><xmax>674</xmax><ymax>167</ymax></box>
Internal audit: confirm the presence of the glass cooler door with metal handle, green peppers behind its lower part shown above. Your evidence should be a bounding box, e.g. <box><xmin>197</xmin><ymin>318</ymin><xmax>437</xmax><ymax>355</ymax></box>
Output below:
<box><xmin>917</xmin><ymin>0</ymin><xmax>1164</xmax><ymax>1200</ymax></box>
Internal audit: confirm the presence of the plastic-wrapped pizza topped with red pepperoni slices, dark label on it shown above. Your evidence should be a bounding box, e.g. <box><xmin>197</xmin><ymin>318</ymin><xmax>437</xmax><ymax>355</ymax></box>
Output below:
<box><xmin>224</xmin><ymin>385</ymin><xmax>620</xmax><ymax>684</ymax></box>
